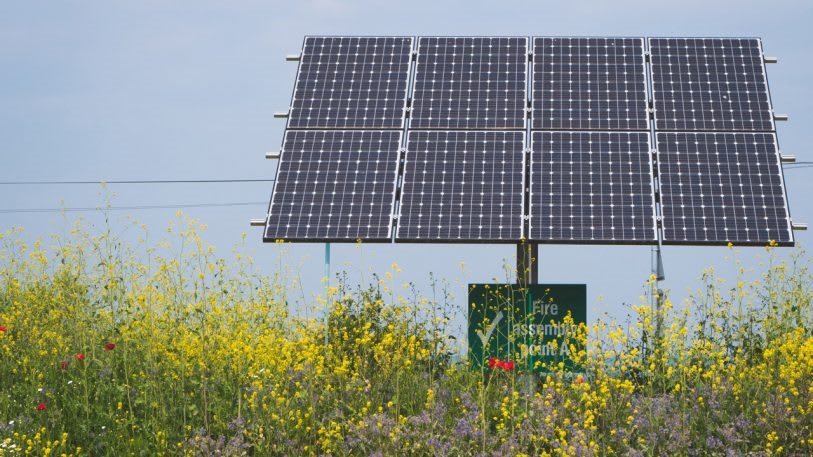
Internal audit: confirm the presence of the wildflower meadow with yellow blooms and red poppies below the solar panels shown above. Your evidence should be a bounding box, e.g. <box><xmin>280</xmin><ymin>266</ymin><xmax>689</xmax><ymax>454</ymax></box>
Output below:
<box><xmin>0</xmin><ymin>216</ymin><xmax>813</xmax><ymax>456</ymax></box>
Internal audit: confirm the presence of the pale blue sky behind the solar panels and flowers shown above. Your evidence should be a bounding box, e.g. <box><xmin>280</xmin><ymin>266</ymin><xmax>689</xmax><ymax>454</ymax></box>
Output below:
<box><xmin>0</xmin><ymin>0</ymin><xmax>813</xmax><ymax>328</ymax></box>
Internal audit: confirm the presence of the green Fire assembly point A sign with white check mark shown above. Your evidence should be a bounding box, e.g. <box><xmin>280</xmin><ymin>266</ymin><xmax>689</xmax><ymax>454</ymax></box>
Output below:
<box><xmin>469</xmin><ymin>284</ymin><xmax>587</xmax><ymax>373</ymax></box>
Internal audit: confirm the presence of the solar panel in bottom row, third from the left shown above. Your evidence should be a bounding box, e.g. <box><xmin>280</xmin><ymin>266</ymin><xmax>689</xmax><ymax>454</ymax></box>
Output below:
<box><xmin>529</xmin><ymin>132</ymin><xmax>656</xmax><ymax>243</ymax></box>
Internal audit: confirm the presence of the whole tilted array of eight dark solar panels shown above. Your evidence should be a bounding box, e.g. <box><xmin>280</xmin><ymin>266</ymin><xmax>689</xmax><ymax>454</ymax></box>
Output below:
<box><xmin>264</xmin><ymin>37</ymin><xmax>793</xmax><ymax>245</ymax></box>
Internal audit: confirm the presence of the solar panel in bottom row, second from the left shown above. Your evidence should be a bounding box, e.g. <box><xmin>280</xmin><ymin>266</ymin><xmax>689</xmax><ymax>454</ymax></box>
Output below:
<box><xmin>396</xmin><ymin>131</ymin><xmax>525</xmax><ymax>242</ymax></box>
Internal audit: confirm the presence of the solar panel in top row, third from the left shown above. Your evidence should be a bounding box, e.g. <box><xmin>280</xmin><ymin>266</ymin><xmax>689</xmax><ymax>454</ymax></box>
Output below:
<box><xmin>532</xmin><ymin>37</ymin><xmax>649</xmax><ymax>131</ymax></box>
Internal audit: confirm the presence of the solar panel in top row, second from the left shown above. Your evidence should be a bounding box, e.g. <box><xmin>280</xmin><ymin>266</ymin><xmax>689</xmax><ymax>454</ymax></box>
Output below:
<box><xmin>409</xmin><ymin>37</ymin><xmax>528</xmax><ymax>130</ymax></box>
